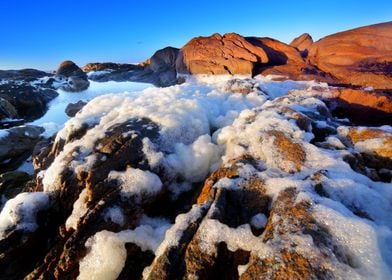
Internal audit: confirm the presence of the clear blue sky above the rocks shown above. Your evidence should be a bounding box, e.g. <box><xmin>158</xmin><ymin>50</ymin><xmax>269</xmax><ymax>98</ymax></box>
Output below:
<box><xmin>0</xmin><ymin>0</ymin><xmax>392</xmax><ymax>70</ymax></box>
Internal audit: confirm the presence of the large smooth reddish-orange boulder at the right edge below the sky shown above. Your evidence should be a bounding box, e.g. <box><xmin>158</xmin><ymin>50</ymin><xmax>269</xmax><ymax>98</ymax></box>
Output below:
<box><xmin>308</xmin><ymin>22</ymin><xmax>392</xmax><ymax>89</ymax></box>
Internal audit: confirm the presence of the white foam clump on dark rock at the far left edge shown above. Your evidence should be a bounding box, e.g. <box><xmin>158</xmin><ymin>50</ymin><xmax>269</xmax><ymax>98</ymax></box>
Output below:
<box><xmin>0</xmin><ymin>192</ymin><xmax>50</xmax><ymax>240</ymax></box>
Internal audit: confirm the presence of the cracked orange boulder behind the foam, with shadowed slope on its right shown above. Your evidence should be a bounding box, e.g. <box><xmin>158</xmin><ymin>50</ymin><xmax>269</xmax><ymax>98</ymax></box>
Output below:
<box><xmin>177</xmin><ymin>33</ymin><xmax>336</xmax><ymax>83</ymax></box>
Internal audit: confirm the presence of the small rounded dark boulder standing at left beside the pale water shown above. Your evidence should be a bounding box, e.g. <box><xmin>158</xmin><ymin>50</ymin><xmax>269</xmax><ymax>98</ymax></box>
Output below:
<box><xmin>56</xmin><ymin>60</ymin><xmax>90</xmax><ymax>92</ymax></box>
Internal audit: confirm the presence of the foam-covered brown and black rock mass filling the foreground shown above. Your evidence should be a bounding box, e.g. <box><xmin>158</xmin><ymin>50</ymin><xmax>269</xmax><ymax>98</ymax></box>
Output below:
<box><xmin>0</xmin><ymin>76</ymin><xmax>392</xmax><ymax>279</ymax></box>
